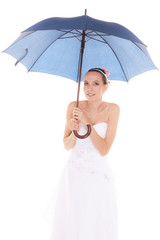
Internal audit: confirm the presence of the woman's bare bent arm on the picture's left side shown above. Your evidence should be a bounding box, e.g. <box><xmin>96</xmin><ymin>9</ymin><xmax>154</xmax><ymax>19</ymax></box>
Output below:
<box><xmin>63</xmin><ymin>102</ymin><xmax>77</xmax><ymax>150</ymax></box>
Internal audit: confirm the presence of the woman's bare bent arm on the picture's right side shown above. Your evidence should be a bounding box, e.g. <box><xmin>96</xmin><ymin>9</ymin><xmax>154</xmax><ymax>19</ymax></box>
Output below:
<box><xmin>90</xmin><ymin>104</ymin><xmax>120</xmax><ymax>156</ymax></box>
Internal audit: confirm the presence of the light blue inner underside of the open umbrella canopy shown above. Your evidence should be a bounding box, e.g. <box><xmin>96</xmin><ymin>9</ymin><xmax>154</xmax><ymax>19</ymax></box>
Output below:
<box><xmin>5</xmin><ymin>29</ymin><xmax>155</xmax><ymax>81</ymax></box>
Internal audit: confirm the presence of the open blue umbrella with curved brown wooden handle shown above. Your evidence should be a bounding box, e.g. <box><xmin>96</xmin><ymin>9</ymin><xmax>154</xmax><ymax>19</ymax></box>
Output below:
<box><xmin>4</xmin><ymin>10</ymin><xmax>156</xmax><ymax>138</ymax></box>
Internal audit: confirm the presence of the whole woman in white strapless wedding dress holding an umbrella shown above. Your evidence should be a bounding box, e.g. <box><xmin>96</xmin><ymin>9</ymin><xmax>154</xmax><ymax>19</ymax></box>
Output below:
<box><xmin>52</xmin><ymin>68</ymin><xmax>120</xmax><ymax>240</ymax></box>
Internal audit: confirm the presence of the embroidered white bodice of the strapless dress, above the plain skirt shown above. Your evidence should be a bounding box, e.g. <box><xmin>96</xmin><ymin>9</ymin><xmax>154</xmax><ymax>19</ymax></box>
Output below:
<box><xmin>68</xmin><ymin>122</ymin><xmax>114</xmax><ymax>180</ymax></box>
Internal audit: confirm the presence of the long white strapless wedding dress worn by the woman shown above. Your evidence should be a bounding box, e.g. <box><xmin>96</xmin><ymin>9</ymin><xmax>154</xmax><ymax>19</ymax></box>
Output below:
<box><xmin>50</xmin><ymin>122</ymin><xmax>118</xmax><ymax>240</ymax></box>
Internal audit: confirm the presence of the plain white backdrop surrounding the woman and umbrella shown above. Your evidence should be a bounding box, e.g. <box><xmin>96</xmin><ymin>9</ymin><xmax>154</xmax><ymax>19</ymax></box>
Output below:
<box><xmin>0</xmin><ymin>0</ymin><xmax>160</xmax><ymax>240</ymax></box>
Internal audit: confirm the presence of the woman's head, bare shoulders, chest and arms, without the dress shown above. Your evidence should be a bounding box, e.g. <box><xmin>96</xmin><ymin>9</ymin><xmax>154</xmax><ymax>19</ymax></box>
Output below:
<box><xmin>64</xmin><ymin>68</ymin><xmax>120</xmax><ymax>156</ymax></box>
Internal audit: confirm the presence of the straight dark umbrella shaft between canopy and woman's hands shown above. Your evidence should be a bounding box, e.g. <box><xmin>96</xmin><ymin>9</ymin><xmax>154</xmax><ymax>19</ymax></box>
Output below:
<box><xmin>76</xmin><ymin>30</ymin><xmax>85</xmax><ymax>107</ymax></box>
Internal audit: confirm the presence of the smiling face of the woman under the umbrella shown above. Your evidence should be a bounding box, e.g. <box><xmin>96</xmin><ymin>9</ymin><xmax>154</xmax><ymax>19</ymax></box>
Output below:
<box><xmin>83</xmin><ymin>72</ymin><xmax>108</xmax><ymax>101</ymax></box>
